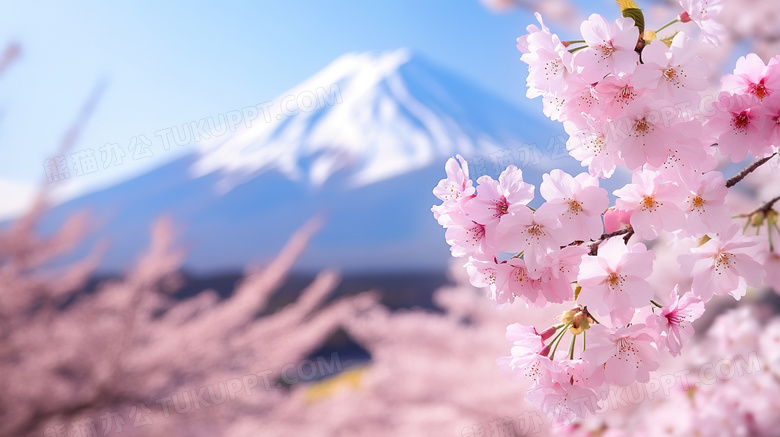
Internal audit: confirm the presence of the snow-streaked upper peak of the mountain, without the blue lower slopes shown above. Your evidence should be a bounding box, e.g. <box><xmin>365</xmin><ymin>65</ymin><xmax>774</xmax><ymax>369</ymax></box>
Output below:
<box><xmin>194</xmin><ymin>49</ymin><xmax>548</xmax><ymax>191</ymax></box>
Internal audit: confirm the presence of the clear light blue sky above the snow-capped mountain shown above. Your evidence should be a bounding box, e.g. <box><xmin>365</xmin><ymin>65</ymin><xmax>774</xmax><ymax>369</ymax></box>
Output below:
<box><xmin>0</xmin><ymin>0</ymin><xmax>616</xmax><ymax>215</ymax></box>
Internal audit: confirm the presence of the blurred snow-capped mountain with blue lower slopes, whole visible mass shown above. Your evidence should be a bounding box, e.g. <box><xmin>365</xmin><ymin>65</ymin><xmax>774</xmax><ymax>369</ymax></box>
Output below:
<box><xmin>38</xmin><ymin>50</ymin><xmax>578</xmax><ymax>271</ymax></box>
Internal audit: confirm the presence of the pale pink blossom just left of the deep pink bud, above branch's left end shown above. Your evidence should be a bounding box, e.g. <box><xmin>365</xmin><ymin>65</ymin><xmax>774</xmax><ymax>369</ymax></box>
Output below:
<box><xmin>539</xmin><ymin>169</ymin><xmax>609</xmax><ymax>242</ymax></box>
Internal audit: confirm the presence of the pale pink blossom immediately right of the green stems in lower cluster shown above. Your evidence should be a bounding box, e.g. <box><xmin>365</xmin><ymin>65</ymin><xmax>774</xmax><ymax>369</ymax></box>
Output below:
<box><xmin>582</xmin><ymin>323</ymin><xmax>660</xmax><ymax>386</ymax></box>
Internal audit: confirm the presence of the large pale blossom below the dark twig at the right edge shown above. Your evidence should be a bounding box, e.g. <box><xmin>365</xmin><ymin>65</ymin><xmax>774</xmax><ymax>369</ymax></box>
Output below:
<box><xmin>677</xmin><ymin>225</ymin><xmax>765</xmax><ymax>302</ymax></box>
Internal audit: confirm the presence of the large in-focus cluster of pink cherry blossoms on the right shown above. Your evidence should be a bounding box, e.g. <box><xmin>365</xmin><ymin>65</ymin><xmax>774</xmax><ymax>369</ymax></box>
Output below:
<box><xmin>432</xmin><ymin>0</ymin><xmax>780</xmax><ymax>421</ymax></box>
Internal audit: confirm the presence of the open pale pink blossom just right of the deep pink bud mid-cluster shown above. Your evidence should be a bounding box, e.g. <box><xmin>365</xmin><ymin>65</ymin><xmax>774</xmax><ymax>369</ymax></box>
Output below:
<box><xmin>615</xmin><ymin>170</ymin><xmax>684</xmax><ymax>240</ymax></box>
